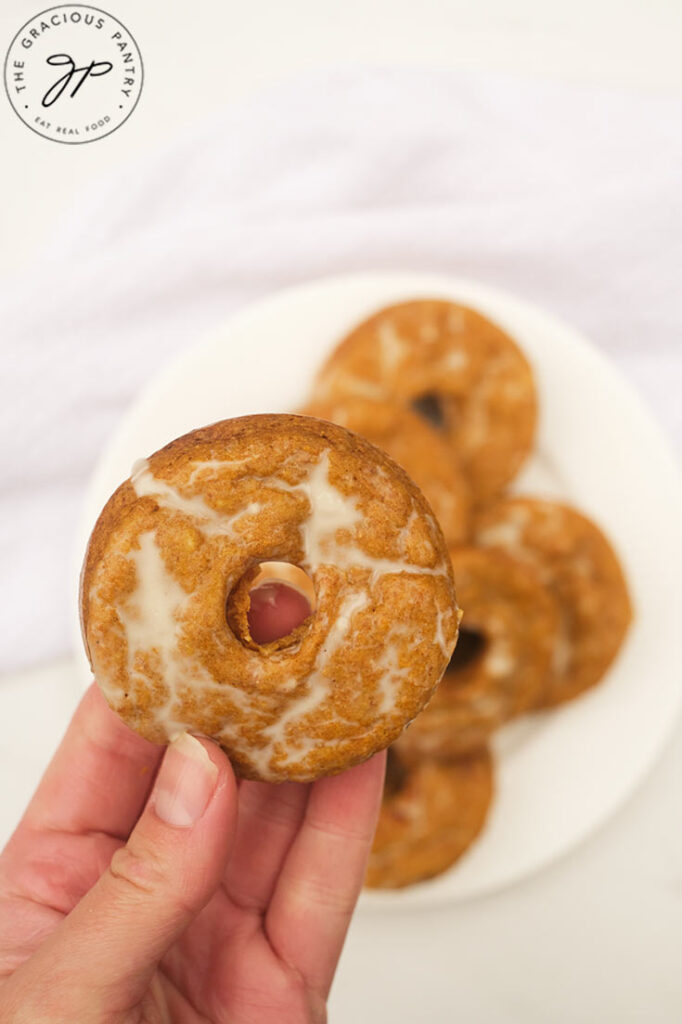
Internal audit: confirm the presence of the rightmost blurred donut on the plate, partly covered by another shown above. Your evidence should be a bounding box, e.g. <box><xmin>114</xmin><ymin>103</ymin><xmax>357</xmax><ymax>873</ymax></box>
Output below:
<box><xmin>476</xmin><ymin>498</ymin><xmax>632</xmax><ymax>707</ymax></box>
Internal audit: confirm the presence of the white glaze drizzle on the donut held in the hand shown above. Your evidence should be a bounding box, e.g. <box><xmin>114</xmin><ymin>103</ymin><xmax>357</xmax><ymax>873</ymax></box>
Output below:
<box><xmin>99</xmin><ymin>452</ymin><xmax>453</xmax><ymax>778</ymax></box>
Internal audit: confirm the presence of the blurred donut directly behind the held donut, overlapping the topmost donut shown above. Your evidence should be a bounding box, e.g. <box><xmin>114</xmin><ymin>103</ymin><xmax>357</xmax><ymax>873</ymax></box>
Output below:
<box><xmin>303</xmin><ymin>395</ymin><xmax>471</xmax><ymax>545</ymax></box>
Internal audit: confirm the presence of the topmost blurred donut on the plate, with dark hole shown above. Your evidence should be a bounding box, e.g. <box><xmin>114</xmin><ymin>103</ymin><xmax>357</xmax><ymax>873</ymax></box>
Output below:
<box><xmin>316</xmin><ymin>299</ymin><xmax>537</xmax><ymax>503</ymax></box>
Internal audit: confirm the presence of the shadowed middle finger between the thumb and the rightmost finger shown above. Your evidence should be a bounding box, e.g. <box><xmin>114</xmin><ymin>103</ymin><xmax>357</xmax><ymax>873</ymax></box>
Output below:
<box><xmin>223</xmin><ymin>779</ymin><xmax>310</xmax><ymax>913</ymax></box>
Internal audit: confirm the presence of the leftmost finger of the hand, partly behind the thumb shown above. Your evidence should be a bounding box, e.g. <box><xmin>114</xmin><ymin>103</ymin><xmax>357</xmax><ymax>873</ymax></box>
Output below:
<box><xmin>12</xmin><ymin>684</ymin><xmax>163</xmax><ymax>840</ymax></box>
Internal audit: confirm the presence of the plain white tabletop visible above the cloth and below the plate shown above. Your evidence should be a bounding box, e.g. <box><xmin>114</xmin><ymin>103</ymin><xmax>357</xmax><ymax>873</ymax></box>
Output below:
<box><xmin>0</xmin><ymin>0</ymin><xmax>682</xmax><ymax>1024</ymax></box>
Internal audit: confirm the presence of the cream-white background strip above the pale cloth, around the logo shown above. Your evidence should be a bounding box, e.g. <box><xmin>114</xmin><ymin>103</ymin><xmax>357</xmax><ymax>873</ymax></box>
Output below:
<box><xmin>0</xmin><ymin>0</ymin><xmax>682</xmax><ymax>270</ymax></box>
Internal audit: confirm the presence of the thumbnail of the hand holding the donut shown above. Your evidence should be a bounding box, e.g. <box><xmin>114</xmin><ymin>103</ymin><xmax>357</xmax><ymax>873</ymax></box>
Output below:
<box><xmin>154</xmin><ymin>732</ymin><xmax>218</xmax><ymax>828</ymax></box>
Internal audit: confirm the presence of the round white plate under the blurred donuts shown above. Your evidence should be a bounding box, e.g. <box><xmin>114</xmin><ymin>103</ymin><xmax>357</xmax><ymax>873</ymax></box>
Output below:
<box><xmin>73</xmin><ymin>273</ymin><xmax>682</xmax><ymax>908</ymax></box>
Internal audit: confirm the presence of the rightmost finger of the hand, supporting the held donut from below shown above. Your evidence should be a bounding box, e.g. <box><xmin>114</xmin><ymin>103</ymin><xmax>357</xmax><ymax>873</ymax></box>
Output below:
<box><xmin>265</xmin><ymin>753</ymin><xmax>386</xmax><ymax>996</ymax></box>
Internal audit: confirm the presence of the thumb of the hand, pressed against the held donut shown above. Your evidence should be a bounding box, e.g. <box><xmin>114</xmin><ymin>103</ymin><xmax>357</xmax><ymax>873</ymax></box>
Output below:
<box><xmin>3</xmin><ymin>733</ymin><xmax>237</xmax><ymax>1020</ymax></box>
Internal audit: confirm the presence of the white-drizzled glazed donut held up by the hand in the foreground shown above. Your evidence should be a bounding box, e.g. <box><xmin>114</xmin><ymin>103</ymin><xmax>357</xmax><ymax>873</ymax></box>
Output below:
<box><xmin>81</xmin><ymin>416</ymin><xmax>459</xmax><ymax>781</ymax></box>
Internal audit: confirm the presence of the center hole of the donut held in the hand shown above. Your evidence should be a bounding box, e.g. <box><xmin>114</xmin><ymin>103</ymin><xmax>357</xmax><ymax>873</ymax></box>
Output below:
<box><xmin>225</xmin><ymin>562</ymin><xmax>316</xmax><ymax>647</ymax></box>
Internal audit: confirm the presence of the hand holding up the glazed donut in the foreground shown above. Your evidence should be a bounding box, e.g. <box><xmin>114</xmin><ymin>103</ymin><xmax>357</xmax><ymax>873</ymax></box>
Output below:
<box><xmin>0</xmin><ymin>589</ymin><xmax>384</xmax><ymax>1024</ymax></box>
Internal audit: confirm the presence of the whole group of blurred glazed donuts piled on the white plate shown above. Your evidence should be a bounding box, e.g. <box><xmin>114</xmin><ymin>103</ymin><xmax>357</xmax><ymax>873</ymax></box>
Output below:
<box><xmin>301</xmin><ymin>299</ymin><xmax>632</xmax><ymax>888</ymax></box>
